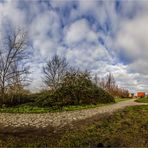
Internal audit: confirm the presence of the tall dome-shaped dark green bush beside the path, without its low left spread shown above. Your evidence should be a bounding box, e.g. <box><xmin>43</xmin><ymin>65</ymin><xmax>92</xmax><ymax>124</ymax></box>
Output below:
<box><xmin>55</xmin><ymin>72</ymin><xmax>114</xmax><ymax>105</ymax></box>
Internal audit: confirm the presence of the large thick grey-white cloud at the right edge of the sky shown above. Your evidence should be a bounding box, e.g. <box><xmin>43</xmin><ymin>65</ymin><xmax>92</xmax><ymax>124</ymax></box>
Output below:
<box><xmin>116</xmin><ymin>15</ymin><xmax>148</xmax><ymax>74</ymax></box>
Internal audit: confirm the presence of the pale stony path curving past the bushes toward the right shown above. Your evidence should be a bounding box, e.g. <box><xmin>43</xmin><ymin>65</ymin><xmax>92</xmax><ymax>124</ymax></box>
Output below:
<box><xmin>0</xmin><ymin>99</ymin><xmax>148</xmax><ymax>128</ymax></box>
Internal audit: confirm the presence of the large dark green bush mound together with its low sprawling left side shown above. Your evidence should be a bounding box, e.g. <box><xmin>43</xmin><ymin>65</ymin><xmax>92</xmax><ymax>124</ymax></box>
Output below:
<box><xmin>36</xmin><ymin>72</ymin><xmax>114</xmax><ymax>107</ymax></box>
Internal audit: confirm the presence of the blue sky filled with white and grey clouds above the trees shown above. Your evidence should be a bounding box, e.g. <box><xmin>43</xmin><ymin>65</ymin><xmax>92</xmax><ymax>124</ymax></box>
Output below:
<box><xmin>0</xmin><ymin>0</ymin><xmax>148</xmax><ymax>92</ymax></box>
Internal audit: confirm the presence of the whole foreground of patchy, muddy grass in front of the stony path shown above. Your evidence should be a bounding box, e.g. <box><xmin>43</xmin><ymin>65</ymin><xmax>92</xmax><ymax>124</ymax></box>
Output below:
<box><xmin>0</xmin><ymin>106</ymin><xmax>148</xmax><ymax>147</ymax></box>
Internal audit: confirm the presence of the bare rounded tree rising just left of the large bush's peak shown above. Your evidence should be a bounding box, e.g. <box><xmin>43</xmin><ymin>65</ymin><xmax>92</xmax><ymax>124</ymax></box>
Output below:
<box><xmin>43</xmin><ymin>55</ymin><xmax>68</xmax><ymax>89</ymax></box>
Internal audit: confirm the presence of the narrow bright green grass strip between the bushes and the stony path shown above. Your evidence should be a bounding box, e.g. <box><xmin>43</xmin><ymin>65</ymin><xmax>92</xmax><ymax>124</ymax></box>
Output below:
<box><xmin>0</xmin><ymin>98</ymin><xmax>131</xmax><ymax>113</ymax></box>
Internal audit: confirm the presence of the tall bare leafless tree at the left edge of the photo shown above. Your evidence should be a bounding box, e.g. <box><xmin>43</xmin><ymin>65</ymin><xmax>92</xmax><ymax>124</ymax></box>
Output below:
<box><xmin>0</xmin><ymin>29</ymin><xmax>29</xmax><ymax>104</ymax></box>
